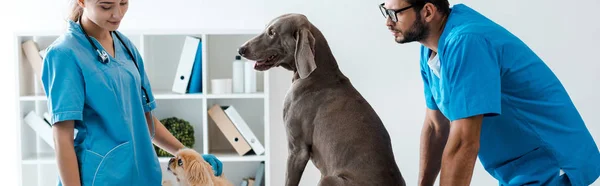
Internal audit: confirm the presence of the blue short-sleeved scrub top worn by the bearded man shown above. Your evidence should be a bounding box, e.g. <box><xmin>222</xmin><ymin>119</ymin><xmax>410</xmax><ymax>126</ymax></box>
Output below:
<box><xmin>421</xmin><ymin>4</ymin><xmax>600</xmax><ymax>185</ymax></box>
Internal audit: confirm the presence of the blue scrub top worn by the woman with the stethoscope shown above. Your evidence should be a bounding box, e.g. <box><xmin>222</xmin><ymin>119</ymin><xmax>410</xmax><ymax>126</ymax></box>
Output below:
<box><xmin>41</xmin><ymin>21</ymin><xmax>162</xmax><ymax>186</ymax></box>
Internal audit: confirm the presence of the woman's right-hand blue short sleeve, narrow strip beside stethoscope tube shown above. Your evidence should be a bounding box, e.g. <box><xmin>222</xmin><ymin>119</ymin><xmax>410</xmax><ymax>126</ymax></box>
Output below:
<box><xmin>123</xmin><ymin>33</ymin><xmax>156</xmax><ymax>112</ymax></box>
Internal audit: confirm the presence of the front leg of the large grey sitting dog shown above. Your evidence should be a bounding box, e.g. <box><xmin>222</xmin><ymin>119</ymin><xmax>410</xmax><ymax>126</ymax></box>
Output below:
<box><xmin>285</xmin><ymin>143</ymin><xmax>310</xmax><ymax>186</ymax></box>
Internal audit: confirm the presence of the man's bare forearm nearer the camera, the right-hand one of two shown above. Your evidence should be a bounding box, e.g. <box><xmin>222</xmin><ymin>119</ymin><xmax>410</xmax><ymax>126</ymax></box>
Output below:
<box><xmin>440</xmin><ymin>115</ymin><xmax>483</xmax><ymax>186</ymax></box>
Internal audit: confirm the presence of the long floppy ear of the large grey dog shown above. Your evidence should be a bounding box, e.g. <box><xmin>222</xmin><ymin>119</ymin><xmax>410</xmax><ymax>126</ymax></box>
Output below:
<box><xmin>295</xmin><ymin>28</ymin><xmax>317</xmax><ymax>79</ymax></box>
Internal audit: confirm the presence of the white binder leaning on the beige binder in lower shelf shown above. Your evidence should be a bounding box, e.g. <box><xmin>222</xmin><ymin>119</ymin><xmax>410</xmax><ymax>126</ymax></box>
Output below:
<box><xmin>224</xmin><ymin>105</ymin><xmax>265</xmax><ymax>155</ymax></box>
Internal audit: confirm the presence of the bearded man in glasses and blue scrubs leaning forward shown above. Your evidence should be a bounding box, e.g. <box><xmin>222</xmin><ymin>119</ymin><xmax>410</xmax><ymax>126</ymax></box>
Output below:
<box><xmin>379</xmin><ymin>0</ymin><xmax>600</xmax><ymax>186</ymax></box>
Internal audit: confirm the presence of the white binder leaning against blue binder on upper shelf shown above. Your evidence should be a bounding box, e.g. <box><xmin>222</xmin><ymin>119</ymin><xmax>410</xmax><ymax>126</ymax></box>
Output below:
<box><xmin>172</xmin><ymin>36</ymin><xmax>200</xmax><ymax>94</ymax></box>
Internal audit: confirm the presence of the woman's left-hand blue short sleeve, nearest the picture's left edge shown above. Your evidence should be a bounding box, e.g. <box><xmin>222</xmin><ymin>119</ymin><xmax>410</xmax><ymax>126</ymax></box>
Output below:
<box><xmin>41</xmin><ymin>48</ymin><xmax>85</xmax><ymax>124</ymax></box>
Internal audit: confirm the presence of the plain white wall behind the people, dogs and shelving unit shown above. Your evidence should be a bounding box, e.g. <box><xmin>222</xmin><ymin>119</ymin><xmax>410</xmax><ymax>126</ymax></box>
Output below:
<box><xmin>0</xmin><ymin>0</ymin><xmax>600</xmax><ymax>185</ymax></box>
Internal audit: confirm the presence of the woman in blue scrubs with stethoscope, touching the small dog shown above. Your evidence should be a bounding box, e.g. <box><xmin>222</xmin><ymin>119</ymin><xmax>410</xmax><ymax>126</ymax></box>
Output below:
<box><xmin>42</xmin><ymin>0</ymin><xmax>222</xmax><ymax>186</ymax></box>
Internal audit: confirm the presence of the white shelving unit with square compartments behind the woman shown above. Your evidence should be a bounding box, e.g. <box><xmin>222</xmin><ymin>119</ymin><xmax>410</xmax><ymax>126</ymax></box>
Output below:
<box><xmin>15</xmin><ymin>30</ymin><xmax>270</xmax><ymax>186</ymax></box>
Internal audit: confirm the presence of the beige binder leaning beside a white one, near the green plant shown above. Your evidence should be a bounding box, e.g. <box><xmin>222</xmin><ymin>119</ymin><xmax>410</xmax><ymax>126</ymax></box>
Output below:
<box><xmin>208</xmin><ymin>104</ymin><xmax>252</xmax><ymax>156</ymax></box>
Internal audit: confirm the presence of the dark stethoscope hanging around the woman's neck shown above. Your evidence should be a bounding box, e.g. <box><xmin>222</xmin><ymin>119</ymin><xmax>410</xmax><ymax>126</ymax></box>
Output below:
<box><xmin>78</xmin><ymin>17</ymin><xmax>155</xmax><ymax>138</ymax></box>
